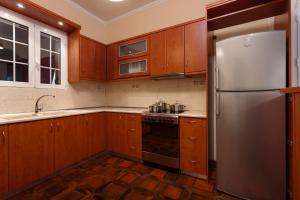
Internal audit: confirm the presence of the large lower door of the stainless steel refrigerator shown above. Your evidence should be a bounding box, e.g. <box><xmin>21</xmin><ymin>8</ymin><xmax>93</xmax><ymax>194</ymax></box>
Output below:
<box><xmin>217</xmin><ymin>92</ymin><xmax>286</xmax><ymax>200</ymax></box>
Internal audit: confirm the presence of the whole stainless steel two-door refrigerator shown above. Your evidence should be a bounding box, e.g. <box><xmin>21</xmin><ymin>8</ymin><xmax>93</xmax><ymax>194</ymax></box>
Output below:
<box><xmin>216</xmin><ymin>31</ymin><xmax>286</xmax><ymax>200</ymax></box>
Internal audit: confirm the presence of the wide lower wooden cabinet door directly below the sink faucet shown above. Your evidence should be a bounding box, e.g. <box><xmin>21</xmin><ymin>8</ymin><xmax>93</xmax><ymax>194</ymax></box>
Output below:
<box><xmin>9</xmin><ymin>120</ymin><xmax>54</xmax><ymax>191</ymax></box>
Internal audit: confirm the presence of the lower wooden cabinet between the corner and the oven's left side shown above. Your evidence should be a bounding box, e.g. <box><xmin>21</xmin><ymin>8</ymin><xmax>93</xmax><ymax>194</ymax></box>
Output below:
<box><xmin>106</xmin><ymin>113</ymin><xmax>142</xmax><ymax>159</ymax></box>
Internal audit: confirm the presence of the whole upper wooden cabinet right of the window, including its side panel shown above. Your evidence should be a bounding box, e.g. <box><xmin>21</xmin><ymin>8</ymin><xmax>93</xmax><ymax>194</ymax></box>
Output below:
<box><xmin>69</xmin><ymin>33</ymin><xmax>106</xmax><ymax>82</ymax></box>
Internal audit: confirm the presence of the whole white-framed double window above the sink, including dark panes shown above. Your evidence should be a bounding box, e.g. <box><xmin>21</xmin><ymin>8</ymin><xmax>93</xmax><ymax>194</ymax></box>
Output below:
<box><xmin>0</xmin><ymin>7</ymin><xmax>67</xmax><ymax>88</ymax></box>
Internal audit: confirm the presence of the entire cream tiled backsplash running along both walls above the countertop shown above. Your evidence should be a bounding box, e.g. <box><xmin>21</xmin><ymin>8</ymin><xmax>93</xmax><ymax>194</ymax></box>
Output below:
<box><xmin>0</xmin><ymin>78</ymin><xmax>206</xmax><ymax>114</ymax></box>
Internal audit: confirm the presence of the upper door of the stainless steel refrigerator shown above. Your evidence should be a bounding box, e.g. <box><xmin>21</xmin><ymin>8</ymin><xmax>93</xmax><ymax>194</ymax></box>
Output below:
<box><xmin>216</xmin><ymin>31</ymin><xmax>286</xmax><ymax>91</ymax></box>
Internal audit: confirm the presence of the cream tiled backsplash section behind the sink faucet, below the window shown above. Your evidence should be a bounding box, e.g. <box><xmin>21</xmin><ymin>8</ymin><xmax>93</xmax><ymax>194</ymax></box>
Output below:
<box><xmin>0</xmin><ymin>82</ymin><xmax>105</xmax><ymax>114</ymax></box>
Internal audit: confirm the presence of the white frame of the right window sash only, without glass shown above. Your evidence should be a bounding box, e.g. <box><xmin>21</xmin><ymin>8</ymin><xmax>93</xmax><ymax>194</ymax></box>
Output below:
<box><xmin>35</xmin><ymin>23</ymin><xmax>68</xmax><ymax>89</ymax></box>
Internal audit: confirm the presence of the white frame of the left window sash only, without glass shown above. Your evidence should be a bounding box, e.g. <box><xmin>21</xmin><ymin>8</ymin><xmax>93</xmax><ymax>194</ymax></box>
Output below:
<box><xmin>0</xmin><ymin>7</ymin><xmax>35</xmax><ymax>87</ymax></box>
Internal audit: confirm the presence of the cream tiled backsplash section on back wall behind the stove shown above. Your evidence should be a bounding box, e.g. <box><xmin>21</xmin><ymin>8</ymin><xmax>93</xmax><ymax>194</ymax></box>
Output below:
<box><xmin>106</xmin><ymin>78</ymin><xmax>206</xmax><ymax>113</ymax></box>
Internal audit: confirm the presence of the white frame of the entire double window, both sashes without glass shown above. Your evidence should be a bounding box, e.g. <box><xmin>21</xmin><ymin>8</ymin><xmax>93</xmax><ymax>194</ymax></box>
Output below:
<box><xmin>0</xmin><ymin>6</ymin><xmax>68</xmax><ymax>89</ymax></box>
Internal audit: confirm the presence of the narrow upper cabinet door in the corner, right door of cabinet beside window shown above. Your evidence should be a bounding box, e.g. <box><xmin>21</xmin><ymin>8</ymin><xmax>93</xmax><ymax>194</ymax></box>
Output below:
<box><xmin>95</xmin><ymin>43</ymin><xmax>106</xmax><ymax>81</ymax></box>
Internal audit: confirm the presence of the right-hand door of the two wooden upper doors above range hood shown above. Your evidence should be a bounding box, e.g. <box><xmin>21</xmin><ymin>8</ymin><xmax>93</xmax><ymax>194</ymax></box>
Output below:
<box><xmin>166</xmin><ymin>26</ymin><xmax>184</xmax><ymax>74</ymax></box>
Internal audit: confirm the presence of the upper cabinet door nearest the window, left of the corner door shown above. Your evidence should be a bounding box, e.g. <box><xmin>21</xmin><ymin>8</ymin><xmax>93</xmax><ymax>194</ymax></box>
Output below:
<box><xmin>80</xmin><ymin>37</ymin><xmax>96</xmax><ymax>80</ymax></box>
